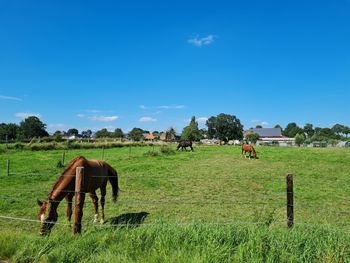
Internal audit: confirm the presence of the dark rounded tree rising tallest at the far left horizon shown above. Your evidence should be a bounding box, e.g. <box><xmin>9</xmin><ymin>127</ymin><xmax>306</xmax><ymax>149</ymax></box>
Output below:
<box><xmin>19</xmin><ymin>116</ymin><xmax>49</xmax><ymax>139</ymax></box>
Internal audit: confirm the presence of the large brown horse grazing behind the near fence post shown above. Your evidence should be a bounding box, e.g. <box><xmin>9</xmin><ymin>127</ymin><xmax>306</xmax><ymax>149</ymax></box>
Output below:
<box><xmin>37</xmin><ymin>156</ymin><xmax>119</xmax><ymax>235</ymax></box>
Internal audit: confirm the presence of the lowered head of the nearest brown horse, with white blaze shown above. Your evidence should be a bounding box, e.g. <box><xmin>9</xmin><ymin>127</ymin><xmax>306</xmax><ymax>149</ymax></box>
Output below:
<box><xmin>37</xmin><ymin>199</ymin><xmax>58</xmax><ymax>236</ymax></box>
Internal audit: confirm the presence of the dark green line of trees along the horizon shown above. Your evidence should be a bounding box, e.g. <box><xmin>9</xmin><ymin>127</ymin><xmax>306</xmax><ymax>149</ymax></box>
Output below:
<box><xmin>0</xmin><ymin>113</ymin><xmax>350</xmax><ymax>145</ymax></box>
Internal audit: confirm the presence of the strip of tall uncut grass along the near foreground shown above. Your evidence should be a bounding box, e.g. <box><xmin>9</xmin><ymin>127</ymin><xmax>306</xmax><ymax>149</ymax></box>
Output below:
<box><xmin>0</xmin><ymin>223</ymin><xmax>350</xmax><ymax>263</ymax></box>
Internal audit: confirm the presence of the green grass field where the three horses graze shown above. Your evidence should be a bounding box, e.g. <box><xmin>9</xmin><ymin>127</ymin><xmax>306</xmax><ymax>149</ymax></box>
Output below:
<box><xmin>0</xmin><ymin>146</ymin><xmax>350</xmax><ymax>262</ymax></box>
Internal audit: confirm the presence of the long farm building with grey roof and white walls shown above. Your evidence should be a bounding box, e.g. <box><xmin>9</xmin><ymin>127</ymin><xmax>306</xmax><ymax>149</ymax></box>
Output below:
<box><xmin>244</xmin><ymin>128</ymin><xmax>295</xmax><ymax>146</ymax></box>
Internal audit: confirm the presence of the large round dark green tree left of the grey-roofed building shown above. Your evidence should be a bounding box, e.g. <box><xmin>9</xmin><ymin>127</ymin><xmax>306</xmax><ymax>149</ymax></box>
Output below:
<box><xmin>206</xmin><ymin>113</ymin><xmax>243</xmax><ymax>142</ymax></box>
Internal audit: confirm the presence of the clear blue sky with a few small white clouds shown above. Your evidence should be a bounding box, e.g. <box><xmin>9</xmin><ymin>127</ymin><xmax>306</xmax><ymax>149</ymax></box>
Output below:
<box><xmin>0</xmin><ymin>0</ymin><xmax>350</xmax><ymax>134</ymax></box>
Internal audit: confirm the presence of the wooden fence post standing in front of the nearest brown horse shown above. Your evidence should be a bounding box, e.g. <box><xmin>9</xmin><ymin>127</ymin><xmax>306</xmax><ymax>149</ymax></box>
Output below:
<box><xmin>73</xmin><ymin>167</ymin><xmax>85</xmax><ymax>234</ymax></box>
